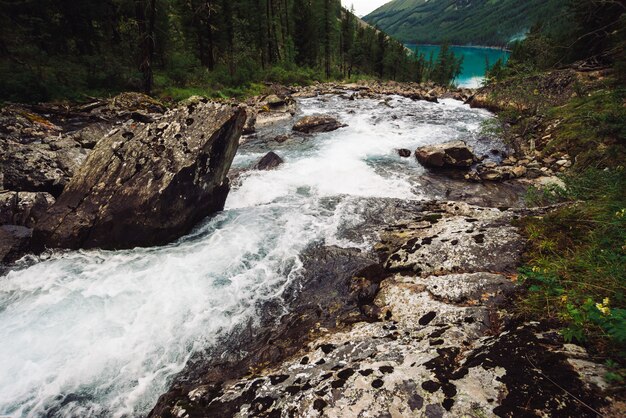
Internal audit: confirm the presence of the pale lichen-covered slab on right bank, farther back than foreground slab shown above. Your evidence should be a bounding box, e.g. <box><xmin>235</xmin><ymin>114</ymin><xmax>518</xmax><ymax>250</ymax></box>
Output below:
<box><xmin>377</xmin><ymin>202</ymin><xmax>524</xmax><ymax>276</ymax></box>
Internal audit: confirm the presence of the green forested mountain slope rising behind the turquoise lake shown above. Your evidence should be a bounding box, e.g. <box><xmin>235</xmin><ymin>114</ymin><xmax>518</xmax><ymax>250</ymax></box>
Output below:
<box><xmin>363</xmin><ymin>0</ymin><xmax>566</xmax><ymax>46</ymax></box>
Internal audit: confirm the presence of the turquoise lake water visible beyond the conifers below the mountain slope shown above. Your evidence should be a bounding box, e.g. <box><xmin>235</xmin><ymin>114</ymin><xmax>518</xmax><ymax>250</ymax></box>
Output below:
<box><xmin>407</xmin><ymin>44</ymin><xmax>510</xmax><ymax>88</ymax></box>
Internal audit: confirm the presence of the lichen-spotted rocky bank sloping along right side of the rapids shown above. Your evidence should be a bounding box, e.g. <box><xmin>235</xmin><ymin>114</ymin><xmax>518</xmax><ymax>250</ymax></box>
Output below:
<box><xmin>151</xmin><ymin>200</ymin><xmax>609</xmax><ymax>417</ymax></box>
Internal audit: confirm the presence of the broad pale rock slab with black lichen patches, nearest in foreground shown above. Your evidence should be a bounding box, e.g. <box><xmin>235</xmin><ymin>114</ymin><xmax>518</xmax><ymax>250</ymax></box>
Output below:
<box><xmin>154</xmin><ymin>298</ymin><xmax>606</xmax><ymax>418</ymax></box>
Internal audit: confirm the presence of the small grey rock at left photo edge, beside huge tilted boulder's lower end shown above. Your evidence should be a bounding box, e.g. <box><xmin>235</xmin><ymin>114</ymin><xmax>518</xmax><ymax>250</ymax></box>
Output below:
<box><xmin>0</xmin><ymin>191</ymin><xmax>54</xmax><ymax>228</ymax></box>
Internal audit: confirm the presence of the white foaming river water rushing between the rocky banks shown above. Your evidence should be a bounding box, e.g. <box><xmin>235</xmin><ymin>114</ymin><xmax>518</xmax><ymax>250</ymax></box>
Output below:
<box><xmin>0</xmin><ymin>96</ymin><xmax>499</xmax><ymax>417</ymax></box>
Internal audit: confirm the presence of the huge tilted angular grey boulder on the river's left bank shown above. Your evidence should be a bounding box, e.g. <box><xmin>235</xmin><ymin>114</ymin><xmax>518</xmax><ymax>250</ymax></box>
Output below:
<box><xmin>33</xmin><ymin>103</ymin><xmax>246</xmax><ymax>250</ymax></box>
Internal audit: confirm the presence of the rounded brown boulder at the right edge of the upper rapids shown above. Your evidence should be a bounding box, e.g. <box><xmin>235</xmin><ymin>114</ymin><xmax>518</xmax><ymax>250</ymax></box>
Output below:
<box><xmin>415</xmin><ymin>141</ymin><xmax>477</xmax><ymax>168</ymax></box>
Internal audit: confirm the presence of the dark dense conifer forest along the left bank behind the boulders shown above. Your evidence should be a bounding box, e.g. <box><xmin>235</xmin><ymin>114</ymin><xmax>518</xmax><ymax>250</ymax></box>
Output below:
<box><xmin>0</xmin><ymin>0</ymin><xmax>464</xmax><ymax>101</ymax></box>
